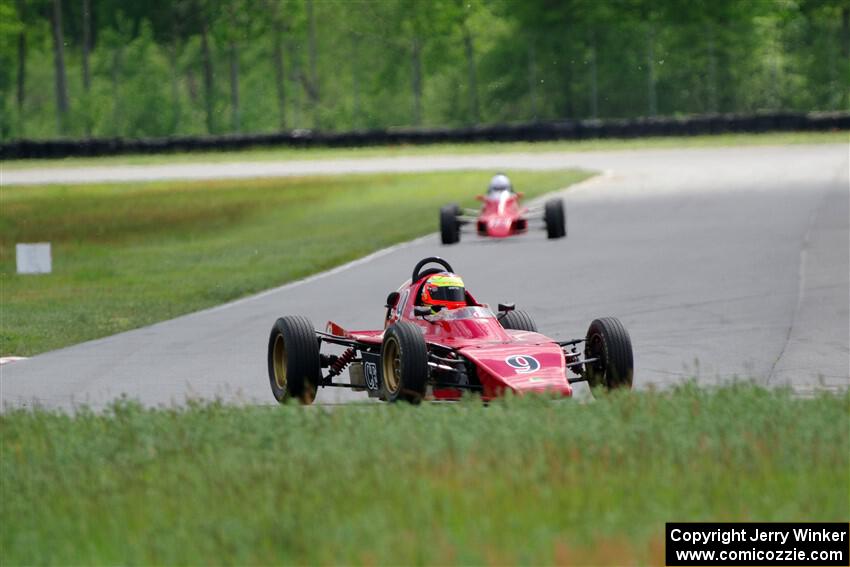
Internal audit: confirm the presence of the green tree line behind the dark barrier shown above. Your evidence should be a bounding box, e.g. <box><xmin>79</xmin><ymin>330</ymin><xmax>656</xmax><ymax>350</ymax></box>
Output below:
<box><xmin>0</xmin><ymin>0</ymin><xmax>850</xmax><ymax>140</ymax></box>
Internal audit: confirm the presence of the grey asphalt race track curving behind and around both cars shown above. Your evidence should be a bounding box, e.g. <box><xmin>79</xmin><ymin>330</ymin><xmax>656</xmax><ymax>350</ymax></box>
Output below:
<box><xmin>0</xmin><ymin>144</ymin><xmax>850</xmax><ymax>407</ymax></box>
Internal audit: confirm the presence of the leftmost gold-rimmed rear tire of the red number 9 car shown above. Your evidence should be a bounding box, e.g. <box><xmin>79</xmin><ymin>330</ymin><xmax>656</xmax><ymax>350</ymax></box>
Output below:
<box><xmin>268</xmin><ymin>315</ymin><xmax>321</xmax><ymax>404</ymax></box>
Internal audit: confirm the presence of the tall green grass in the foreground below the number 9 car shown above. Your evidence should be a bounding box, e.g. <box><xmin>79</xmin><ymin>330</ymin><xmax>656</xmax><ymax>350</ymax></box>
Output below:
<box><xmin>0</xmin><ymin>384</ymin><xmax>850</xmax><ymax>565</ymax></box>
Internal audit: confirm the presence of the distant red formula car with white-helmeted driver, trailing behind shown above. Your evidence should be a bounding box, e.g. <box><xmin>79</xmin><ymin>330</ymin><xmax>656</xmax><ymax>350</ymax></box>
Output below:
<box><xmin>440</xmin><ymin>173</ymin><xmax>567</xmax><ymax>244</ymax></box>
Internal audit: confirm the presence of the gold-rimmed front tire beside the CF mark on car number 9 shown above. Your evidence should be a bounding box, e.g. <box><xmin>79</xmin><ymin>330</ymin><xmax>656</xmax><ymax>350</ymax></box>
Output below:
<box><xmin>381</xmin><ymin>321</ymin><xmax>428</xmax><ymax>404</ymax></box>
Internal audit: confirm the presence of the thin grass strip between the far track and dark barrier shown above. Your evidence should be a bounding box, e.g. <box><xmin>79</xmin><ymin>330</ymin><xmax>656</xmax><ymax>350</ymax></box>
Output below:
<box><xmin>2</xmin><ymin>131</ymin><xmax>850</xmax><ymax>170</ymax></box>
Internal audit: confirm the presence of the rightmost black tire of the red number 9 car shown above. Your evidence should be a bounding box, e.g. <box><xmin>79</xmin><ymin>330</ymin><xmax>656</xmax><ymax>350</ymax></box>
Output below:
<box><xmin>584</xmin><ymin>317</ymin><xmax>634</xmax><ymax>391</ymax></box>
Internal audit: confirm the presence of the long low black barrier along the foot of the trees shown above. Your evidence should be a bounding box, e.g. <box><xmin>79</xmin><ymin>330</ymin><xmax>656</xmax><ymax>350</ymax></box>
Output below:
<box><xmin>0</xmin><ymin>112</ymin><xmax>850</xmax><ymax>160</ymax></box>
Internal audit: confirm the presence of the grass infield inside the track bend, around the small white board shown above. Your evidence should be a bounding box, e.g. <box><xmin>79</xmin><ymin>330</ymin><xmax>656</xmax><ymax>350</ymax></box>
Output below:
<box><xmin>0</xmin><ymin>171</ymin><xmax>590</xmax><ymax>356</ymax></box>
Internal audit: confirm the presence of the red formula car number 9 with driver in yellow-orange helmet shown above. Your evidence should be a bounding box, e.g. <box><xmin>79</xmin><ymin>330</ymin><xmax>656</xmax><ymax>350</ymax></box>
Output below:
<box><xmin>268</xmin><ymin>257</ymin><xmax>633</xmax><ymax>403</ymax></box>
